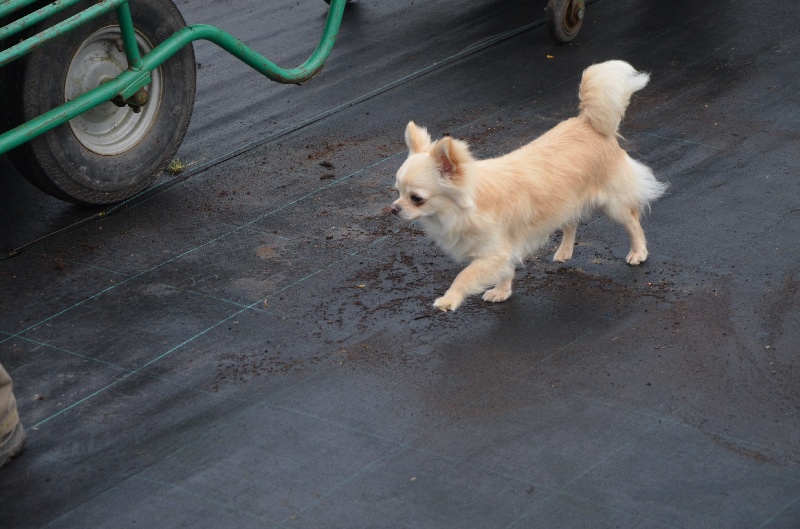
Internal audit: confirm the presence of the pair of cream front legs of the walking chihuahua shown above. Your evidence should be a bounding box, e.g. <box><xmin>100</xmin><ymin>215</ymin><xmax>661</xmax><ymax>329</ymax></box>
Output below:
<box><xmin>433</xmin><ymin>257</ymin><xmax>514</xmax><ymax>312</ymax></box>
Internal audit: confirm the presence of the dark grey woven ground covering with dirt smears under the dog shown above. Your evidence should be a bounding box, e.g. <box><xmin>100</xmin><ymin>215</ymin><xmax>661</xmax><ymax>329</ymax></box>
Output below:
<box><xmin>0</xmin><ymin>0</ymin><xmax>800</xmax><ymax>529</ymax></box>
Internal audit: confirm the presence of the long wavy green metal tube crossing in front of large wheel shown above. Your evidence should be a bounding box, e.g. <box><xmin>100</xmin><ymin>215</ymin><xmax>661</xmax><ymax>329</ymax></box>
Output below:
<box><xmin>0</xmin><ymin>0</ymin><xmax>346</xmax><ymax>154</ymax></box>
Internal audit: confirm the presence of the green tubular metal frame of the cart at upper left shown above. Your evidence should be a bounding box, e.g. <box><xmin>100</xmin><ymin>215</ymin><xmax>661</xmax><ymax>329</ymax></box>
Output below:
<box><xmin>0</xmin><ymin>0</ymin><xmax>347</xmax><ymax>154</ymax></box>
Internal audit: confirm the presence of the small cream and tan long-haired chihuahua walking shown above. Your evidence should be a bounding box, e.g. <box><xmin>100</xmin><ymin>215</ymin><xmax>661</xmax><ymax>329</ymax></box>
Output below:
<box><xmin>392</xmin><ymin>61</ymin><xmax>667</xmax><ymax>311</ymax></box>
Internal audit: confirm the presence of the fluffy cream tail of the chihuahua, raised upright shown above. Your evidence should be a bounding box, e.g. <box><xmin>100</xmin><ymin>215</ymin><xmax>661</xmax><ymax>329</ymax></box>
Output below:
<box><xmin>579</xmin><ymin>61</ymin><xmax>650</xmax><ymax>136</ymax></box>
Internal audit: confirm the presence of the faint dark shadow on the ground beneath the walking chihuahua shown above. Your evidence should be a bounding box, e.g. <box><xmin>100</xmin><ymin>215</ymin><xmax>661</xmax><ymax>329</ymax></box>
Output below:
<box><xmin>437</xmin><ymin>267</ymin><xmax>655</xmax><ymax>386</ymax></box>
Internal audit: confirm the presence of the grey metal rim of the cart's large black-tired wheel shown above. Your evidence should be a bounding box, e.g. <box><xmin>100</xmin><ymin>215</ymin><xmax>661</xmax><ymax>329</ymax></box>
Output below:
<box><xmin>64</xmin><ymin>26</ymin><xmax>163</xmax><ymax>156</ymax></box>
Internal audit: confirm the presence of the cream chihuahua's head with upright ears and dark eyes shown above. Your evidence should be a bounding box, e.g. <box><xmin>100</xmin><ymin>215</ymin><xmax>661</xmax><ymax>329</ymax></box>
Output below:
<box><xmin>392</xmin><ymin>121</ymin><xmax>474</xmax><ymax>220</ymax></box>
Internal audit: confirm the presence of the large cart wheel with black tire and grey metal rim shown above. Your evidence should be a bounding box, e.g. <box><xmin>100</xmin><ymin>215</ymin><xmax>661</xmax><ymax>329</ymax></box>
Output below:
<box><xmin>6</xmin><ymin>0</ymin><xmax>196</xmax><ymax>204</ymax></box>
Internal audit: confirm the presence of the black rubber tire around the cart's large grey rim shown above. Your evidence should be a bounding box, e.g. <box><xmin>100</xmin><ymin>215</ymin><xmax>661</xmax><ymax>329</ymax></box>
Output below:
<box><xmin>7</xmin><ymin>0</ymin><xmax>196</xmax><ymax>205</ymax></box>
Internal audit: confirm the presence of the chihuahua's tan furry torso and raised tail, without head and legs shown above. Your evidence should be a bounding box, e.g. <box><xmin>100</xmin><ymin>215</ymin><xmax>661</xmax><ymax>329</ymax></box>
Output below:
<box><xmin>469</xmin><ymin>61</ymin><xmax>667</xmax><ymax>257</ymax></box>
